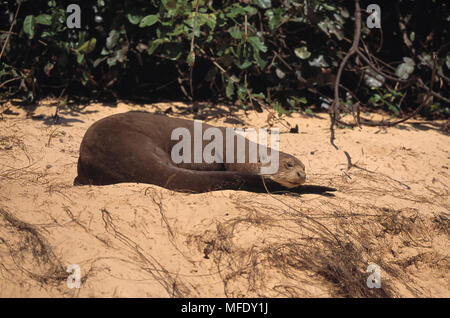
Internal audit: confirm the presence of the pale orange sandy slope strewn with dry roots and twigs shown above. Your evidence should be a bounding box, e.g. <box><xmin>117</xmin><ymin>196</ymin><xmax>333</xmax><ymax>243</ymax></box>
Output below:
<box><xmin>0</xmin><ymin>103</ymin><xmax>450</xmax><ymax>297</ymax></box>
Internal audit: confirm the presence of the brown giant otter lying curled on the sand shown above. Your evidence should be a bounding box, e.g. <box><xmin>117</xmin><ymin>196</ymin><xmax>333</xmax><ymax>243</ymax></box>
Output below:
<box><xmin>74</xmin><ymin>112</ymin><xmax>306</xmax><ymax>192</ymax></box>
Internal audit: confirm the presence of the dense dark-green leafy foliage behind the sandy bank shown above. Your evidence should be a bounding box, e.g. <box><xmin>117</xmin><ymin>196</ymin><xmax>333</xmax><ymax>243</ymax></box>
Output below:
<box><xmin>0</xmin><ymin>0</ymin><xmax>450</xmax><ymax>115</ymax></box>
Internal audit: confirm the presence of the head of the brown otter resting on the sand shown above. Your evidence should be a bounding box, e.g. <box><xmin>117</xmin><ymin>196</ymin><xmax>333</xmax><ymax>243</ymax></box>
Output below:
<box><xmin>264</xmin><ymin>152</ymin><xmax>306</xmax><ymax>188</ymax></box>
